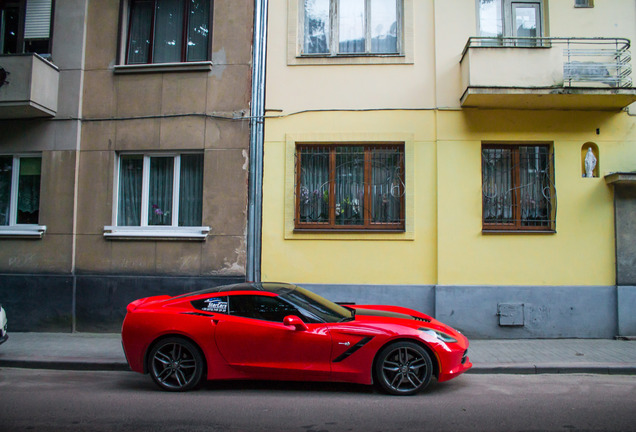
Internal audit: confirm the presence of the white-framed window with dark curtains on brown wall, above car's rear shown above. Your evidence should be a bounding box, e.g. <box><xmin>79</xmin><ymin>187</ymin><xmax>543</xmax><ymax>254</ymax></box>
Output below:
<box><xmin>116</xmin><ymin>153</ymin><xmax>203</xmax><ymax>227</ymax></box>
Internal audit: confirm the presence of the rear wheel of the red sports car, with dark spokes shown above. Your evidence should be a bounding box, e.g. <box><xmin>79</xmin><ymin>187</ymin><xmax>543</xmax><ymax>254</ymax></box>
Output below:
<box><xmin>148</xmin><ymin>337</ymin><xmax>205</xmax><ymax>391</ymax></box>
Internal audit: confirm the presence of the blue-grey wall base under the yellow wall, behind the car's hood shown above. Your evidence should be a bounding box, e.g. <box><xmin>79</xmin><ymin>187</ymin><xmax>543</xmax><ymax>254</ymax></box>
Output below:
<box><xmin>301</xmin><ymin>284</ymin><xmax>620</xmax><ymax>339</ymax></box>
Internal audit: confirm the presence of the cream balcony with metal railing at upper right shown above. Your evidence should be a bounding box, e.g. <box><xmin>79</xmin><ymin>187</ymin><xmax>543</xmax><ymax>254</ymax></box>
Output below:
<box><xmin>460</xmin><ymin>37</ymin><xmax>636</xmax><ymax>111</ymax></box>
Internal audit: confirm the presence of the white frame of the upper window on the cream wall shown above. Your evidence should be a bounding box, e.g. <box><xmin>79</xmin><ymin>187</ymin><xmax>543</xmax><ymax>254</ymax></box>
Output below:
<box><xmin>298</xmin><ymin>0</ymin><xmax>404</xmax><ymax>57</ymax></box>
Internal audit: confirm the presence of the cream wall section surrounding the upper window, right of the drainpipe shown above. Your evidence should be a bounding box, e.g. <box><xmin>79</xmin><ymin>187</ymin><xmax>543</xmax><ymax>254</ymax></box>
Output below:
<box><xmin>266</xmin><ymin>0</ymin><xmax>435</xmax><ymax>113</ymax></box>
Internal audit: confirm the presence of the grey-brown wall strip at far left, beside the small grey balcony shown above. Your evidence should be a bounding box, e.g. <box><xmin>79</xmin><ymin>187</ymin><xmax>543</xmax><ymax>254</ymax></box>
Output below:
<box><xmin>0</xmin><ymin>0</ymin><xmax>87</xmax><ymax>273</ymax></box>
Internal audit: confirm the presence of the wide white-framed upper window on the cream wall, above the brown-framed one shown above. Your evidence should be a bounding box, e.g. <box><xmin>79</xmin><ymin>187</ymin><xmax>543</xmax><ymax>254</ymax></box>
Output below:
<box><xmin>299</xmin><ymin>0</ymin><xmax>402</xmax><ymax>56</ymax></box>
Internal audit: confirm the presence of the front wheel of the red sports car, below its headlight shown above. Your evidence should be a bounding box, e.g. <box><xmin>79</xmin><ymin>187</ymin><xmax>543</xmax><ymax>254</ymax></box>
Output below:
<box><xmin>375</xmin><ymin>341</ymin><xmax>433</xmax><ymax>396</ymax></box>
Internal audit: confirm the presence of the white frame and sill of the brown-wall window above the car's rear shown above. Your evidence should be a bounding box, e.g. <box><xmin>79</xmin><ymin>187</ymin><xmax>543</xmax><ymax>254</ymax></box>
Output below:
<box><xmin>104</xmin><ymin>152</ymin><xmax>210</xmax><ymax>240</ymax></box>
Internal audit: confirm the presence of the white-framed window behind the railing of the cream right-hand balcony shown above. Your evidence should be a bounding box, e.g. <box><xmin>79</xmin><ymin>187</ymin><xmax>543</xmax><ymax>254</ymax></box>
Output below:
<box><xmin>477</xmin><ymin>0</ymin><xmax>543</xmax><ymax>38</ymax></box>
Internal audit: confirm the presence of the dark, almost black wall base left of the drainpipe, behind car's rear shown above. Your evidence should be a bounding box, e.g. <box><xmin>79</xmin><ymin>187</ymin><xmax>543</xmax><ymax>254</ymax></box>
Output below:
<box><xmin>0</xmin><ymin>274</ymin><xmax>245</xmax><ymax>332</ymax></box>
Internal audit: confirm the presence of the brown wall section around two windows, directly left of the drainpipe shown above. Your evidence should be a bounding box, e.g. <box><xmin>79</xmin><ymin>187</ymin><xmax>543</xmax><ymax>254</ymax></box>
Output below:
<box><xmin>72</xmin><ymin>0</ymin><xmax>253</xmax><ymax>275</ymax></box>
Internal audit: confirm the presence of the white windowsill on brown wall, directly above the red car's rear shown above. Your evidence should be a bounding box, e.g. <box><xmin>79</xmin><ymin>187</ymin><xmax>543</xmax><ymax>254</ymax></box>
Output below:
<box><xmin>104</xmin><ymin>226</ymin><xmax>210</xmax><ymax>241</ymax></box>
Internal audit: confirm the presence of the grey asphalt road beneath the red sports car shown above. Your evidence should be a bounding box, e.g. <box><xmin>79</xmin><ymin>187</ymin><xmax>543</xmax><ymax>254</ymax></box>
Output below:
<box><xmin>0</xmin><ymin>368</ymin><xmax>636</xmax><ymax>432</ymax></box>
